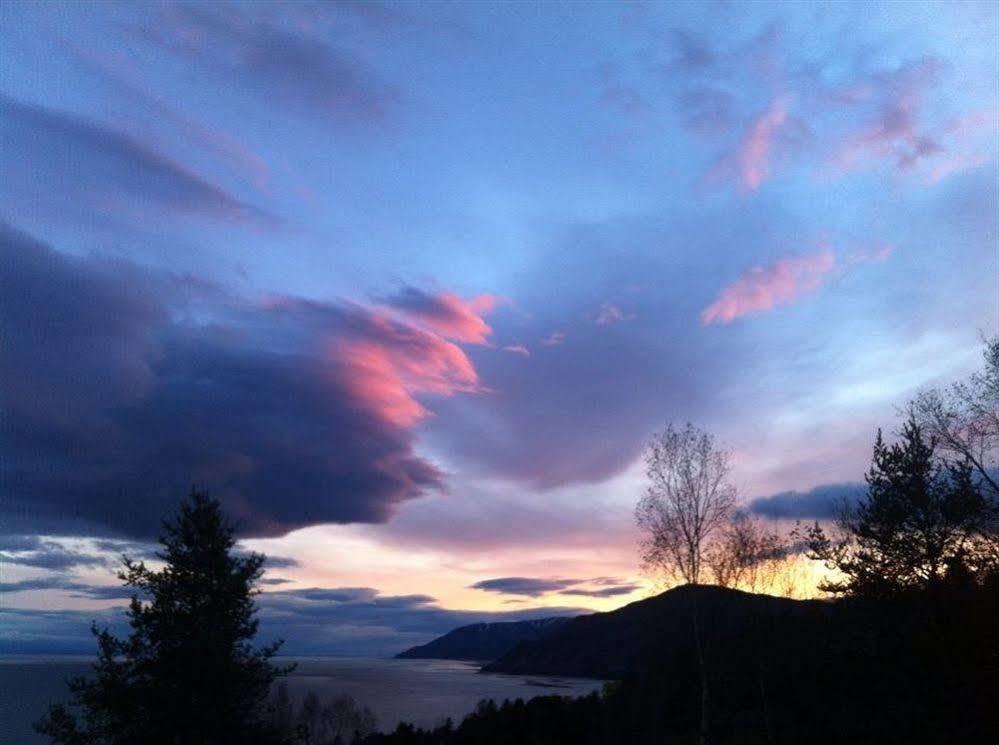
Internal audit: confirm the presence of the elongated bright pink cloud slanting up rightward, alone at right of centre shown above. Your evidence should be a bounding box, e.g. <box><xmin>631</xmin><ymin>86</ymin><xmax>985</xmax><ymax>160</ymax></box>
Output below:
<box><xmin>701</xmin><ymin>244</ymin><xmax>894</xmax><ymax>326</ymax></box>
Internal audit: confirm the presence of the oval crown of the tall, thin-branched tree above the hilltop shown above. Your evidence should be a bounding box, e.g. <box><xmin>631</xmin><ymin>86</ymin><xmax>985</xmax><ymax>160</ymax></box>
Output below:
<box><xmin>635</xmin><ymin>423</ymin><xmax>735</xmax><ymax>585</ymax></box>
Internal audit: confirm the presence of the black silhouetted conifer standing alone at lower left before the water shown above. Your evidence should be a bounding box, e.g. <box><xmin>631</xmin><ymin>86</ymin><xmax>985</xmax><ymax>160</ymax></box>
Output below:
<box><xmin>36</xmin><ymin>490</ymin><xmax>290</xmax><ymax>745</ymax></box>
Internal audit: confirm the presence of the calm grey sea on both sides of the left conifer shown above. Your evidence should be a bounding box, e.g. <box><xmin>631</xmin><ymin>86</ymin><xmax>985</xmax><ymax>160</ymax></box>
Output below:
<box><xmin>0</xmin><ymin>656</ymin><xmax>601</xmax><ymax>745</ymax></box>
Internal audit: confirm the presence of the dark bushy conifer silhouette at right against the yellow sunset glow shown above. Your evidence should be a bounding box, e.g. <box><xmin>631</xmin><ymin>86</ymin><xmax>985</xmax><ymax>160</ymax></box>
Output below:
<box><xmin>806</xmin><ymin>417</ymin><xmax>994</xmax><ymax>597</ymax></box>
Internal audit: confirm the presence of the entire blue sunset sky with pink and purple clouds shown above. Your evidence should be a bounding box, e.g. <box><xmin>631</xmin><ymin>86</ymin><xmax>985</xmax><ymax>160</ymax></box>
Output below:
<box><xmin>0</xmin><ymin>0</ymin><xmax>999</xmax><ymax>655</ymax></box>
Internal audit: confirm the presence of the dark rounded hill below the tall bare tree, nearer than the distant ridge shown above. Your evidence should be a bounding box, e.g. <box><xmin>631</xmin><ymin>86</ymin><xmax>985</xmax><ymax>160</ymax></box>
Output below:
<box><xmin>482</xmin><ymin>585</ymin><xmax>832</xmax><ymax>679</ymax></box>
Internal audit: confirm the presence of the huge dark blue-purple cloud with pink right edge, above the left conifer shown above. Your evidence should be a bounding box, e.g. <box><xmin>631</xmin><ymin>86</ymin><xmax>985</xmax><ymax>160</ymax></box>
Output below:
<box><xmin>0</xmin><ymin>227</ymin><xmax>488</xmax><ymax>538</ymax></box>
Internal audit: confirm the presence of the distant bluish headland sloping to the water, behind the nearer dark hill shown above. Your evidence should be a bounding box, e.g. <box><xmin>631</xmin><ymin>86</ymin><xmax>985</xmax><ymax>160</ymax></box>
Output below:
<box><xmin>396</xmin><ymin>617</ymin><xmax>572</xmax><ymax>660</ymax></box>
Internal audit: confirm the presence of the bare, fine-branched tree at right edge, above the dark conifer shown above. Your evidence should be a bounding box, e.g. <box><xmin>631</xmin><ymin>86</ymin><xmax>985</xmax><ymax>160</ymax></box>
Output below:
<box><xmin>912</xmin><ymin>337</ymin><xmax>999</xmax><ymax>499</ymax></box>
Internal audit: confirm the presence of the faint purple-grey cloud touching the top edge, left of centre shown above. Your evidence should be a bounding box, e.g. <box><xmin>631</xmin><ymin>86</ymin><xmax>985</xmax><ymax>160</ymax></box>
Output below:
<box><xmin>139</xmin><ymin>5</ymin><xmax>399</xmax><ymax>124</ymax></box>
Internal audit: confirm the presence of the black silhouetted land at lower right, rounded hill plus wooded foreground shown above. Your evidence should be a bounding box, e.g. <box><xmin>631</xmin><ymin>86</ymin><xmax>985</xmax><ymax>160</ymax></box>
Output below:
<box><xmin>372</xmin><ymin>582</ymin><xmax>999</xmax><ymax>745</ymax></box>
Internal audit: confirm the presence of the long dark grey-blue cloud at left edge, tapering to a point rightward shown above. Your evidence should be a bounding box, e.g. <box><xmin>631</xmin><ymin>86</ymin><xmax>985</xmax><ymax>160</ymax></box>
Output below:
<box><xmin>0</xmin><ymin>95</ymin><xmax>279</xmax><ymax>227</ymax></box>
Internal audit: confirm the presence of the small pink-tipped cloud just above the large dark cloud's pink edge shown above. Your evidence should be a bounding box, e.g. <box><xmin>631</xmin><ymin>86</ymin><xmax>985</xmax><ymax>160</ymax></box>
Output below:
<box><xmin>388</xmin><ymin>287</ymin><xmax>498</xmax><ymax>344</ymax></box>
